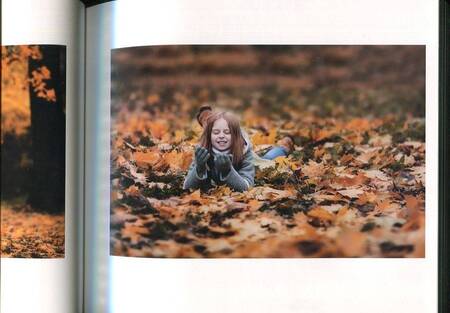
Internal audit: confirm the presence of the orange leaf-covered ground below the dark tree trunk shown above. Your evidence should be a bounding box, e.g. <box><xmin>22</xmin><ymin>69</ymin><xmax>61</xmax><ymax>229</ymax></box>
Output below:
<box><xmin>1</xmin><ymin>202</ymin><xmax>64</xmax><ymax>258</ymax></box>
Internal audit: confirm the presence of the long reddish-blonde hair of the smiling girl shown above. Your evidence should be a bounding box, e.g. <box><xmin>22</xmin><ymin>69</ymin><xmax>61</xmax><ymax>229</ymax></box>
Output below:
<box><xmin>200</xmin><ymin>112</ymin><xmax>245</xmax><ymax>166</ymax></box>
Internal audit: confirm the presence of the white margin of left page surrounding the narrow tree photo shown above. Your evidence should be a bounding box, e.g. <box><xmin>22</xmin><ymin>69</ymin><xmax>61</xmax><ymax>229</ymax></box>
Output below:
<box><xmin>0</xmin><ymin>0</ymin><xmax>84</xmax><ymax>313</ymax></box>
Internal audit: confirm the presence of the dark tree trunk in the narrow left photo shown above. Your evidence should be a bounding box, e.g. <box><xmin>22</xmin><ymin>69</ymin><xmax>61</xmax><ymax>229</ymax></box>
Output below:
<box><xmin>28</xmin><ymin>46</ymin><xmax>66</xmax><ymax>213</ymax></box>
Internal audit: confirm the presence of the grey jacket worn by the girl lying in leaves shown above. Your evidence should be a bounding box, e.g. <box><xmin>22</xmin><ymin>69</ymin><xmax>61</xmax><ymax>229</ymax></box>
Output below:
<box><xmin>183</xmin><ymin>135</ymin><xmax>255</xmax><ymax>191</ymax></box>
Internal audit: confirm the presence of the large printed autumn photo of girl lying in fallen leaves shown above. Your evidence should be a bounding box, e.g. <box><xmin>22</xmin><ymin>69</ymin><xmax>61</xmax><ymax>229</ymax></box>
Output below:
<box><xmin>110</xmin><ymin>45</ymin><xmax>425</xmax><ymax>258</ymax></box>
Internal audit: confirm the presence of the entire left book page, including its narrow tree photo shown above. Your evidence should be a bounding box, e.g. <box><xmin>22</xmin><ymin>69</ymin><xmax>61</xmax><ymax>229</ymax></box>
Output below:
<box><xmin>1</xmin><ymin>0</ymin><xmax>84</xmax><ymax>312</ymax></box>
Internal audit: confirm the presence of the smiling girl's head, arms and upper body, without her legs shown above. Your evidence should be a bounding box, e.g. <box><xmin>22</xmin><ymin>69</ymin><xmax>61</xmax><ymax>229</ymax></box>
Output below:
<box><xmin>183</xmin><ymin>112</ymin><xmax>255</xmax><ymax>191</ymax></box>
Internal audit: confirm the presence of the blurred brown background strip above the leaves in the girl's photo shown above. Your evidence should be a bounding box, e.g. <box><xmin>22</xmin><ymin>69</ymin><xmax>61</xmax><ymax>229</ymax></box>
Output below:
<box><xmin>111</xmin><ymin>45</ymin><xmax>425</xmax><ymax>117</ymax></box>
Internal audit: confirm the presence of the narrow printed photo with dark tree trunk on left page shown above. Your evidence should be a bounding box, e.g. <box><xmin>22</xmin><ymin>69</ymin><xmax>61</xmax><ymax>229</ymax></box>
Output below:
<box><xmin>1</xmin><ymin>45</ymin><xmax>66</xmax><ymax>258</ymax></box>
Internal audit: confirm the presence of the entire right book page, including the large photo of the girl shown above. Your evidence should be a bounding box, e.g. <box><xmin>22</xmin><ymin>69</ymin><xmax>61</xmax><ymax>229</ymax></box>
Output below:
<box><xmin>86</xmin><ymin>1</ymin><xmax>438</xmax><ymax>312</ymax></box>
